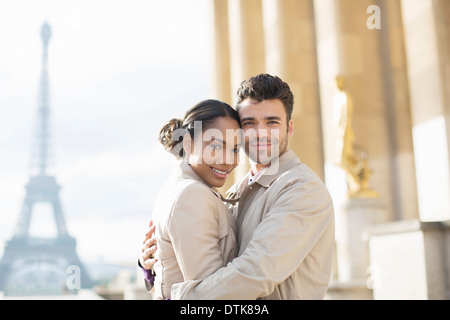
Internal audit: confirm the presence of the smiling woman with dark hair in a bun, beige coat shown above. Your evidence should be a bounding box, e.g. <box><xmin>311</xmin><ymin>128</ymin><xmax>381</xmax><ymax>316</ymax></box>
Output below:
<box><xmin>143</xmin><ymin>100</ymin><xmax>241</xmax><ymax>299</ymax></box>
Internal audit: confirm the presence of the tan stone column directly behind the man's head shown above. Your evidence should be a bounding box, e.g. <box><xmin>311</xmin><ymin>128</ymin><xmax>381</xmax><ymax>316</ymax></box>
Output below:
<box><xmin>263</xmin><ymin>0</ymin><xmax>324</xmax><ymax>178</ymax></box>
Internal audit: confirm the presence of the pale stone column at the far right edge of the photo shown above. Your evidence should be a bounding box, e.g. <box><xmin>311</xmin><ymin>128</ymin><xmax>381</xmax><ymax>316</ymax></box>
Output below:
<box><xmin>402</xmin><ymin>0</ymin><xmax>450</xmax><ymax>221</ymax></box>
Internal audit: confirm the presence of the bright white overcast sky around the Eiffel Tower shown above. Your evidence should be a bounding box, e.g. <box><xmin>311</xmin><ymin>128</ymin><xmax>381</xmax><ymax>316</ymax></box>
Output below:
<box><xmin>0</xmin><ymin>0</ymin><xmax>212</xmax><ymax>263</ymax></box>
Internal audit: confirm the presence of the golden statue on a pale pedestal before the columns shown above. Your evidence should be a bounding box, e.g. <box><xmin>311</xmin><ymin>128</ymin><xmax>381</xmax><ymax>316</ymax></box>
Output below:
<box><xmin>333</xmin><ymin>76</ymin><xmax>378</xmax><ymax>198</ymax></box>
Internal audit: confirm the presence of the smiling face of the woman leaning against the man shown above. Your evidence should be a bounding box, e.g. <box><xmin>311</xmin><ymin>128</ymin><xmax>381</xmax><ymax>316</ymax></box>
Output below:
<box><xmin>183</xmin><ymin>117</ymin><xmax>241</xmax><ymax>188</ymax></box>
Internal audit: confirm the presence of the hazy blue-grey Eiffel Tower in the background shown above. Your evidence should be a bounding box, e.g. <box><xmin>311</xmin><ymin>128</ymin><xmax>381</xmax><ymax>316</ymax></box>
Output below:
<box><xmin>0</xmin><ymin>22</ymin><xmax>91</xmax><ymax>296</ymax></box>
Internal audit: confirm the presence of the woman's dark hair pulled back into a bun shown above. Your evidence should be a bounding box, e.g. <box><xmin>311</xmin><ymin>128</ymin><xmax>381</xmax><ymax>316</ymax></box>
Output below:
<box><xmin>159</xmin><ymin>99</ymin><xmax>241</xmax><ymax>158</ymax></box>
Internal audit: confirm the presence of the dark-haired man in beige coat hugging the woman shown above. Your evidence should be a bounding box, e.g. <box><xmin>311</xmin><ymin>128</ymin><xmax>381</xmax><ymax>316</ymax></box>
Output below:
<box><xmin>140</xmin><ymin>74</ymin><xmax>334</xmax><ymax>300</ymax></box>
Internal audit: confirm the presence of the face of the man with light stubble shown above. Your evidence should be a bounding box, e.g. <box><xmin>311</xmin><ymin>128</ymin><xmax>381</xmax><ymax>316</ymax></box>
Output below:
<box><xmin>239</xmin><ymin>98</ymin><xmax>294</xmax><ymax>165</ymax></box>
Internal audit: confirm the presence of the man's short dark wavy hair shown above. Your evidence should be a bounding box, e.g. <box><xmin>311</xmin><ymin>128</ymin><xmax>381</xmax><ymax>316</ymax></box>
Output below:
<box><xmin>236</xmin><ymin>73</ymin><xmax>294</xmax><ymax>122</ymax></box>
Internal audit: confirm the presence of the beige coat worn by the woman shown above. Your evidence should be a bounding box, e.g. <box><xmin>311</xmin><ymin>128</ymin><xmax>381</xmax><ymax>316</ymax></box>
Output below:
<box><xmin>153</xmin><ymin>161</ymin><xmax>237</xmax><ymax>299</ymax></box>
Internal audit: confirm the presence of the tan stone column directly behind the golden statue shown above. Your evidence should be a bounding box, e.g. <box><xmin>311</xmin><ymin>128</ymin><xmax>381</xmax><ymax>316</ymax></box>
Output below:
<box><xmin>314</xmin><ymin>0</ymin><xmax>394</xmax><ymax>218</ymax></box>
